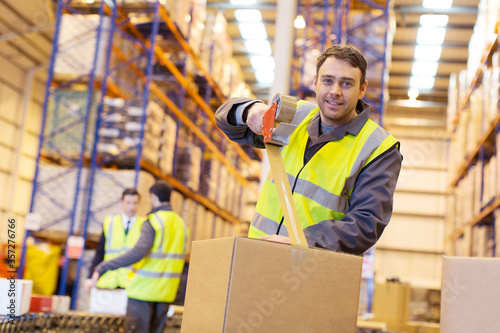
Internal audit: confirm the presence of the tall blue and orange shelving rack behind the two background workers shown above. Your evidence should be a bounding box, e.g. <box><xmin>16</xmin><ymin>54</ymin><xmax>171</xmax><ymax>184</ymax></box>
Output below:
<box><xmin>20</xmin><ymin>0</ymin><xmax>260</xmax><ymax>308</ymax></box>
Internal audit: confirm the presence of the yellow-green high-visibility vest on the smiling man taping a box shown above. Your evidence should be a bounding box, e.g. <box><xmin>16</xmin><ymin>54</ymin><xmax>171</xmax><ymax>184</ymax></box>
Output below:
<box><xmin>248</xmin><ymin>101</ymin><xmax>398</xmax><ymax>238</ymax></box>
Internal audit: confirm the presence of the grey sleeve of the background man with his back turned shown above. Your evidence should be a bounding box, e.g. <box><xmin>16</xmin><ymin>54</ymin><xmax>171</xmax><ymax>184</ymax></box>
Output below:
<box><xmin>95</xmin><ymin>220</ymin><xmax>155</xmax><ymax>276</ymax></box>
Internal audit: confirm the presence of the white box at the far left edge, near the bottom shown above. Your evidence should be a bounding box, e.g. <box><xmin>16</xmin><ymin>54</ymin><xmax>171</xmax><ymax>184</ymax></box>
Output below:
<box><xmin>0</xmin><ymin>278</ymin><xmax>33</xmax><ymax>317</ymax></box>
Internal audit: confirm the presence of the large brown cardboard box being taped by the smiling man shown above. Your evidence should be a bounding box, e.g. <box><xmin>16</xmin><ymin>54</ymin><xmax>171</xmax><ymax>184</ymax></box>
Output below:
<box><xmin>181</xmin><ymin>237</ymin><xmax>363</xmax><ymax>333</ymax></box>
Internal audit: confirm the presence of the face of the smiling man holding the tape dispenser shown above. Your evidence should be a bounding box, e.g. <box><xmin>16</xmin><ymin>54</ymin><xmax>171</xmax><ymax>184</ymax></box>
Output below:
<box><xmin>314</xmin><ymin>57</ymin><xmax>368</xmax><ymax>127</ymax></box>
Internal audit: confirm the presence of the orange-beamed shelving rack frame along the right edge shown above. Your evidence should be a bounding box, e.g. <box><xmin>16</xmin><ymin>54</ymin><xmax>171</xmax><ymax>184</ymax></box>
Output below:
<box><xmin>446</xmin><ymin>28</ymin><xmax>500</xmax><ymax>254</ymax></box>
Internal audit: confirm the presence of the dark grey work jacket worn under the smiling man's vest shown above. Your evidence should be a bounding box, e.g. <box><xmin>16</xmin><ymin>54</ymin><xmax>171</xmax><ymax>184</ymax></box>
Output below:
<box><xmin>215</xmin><ymin>98</ymin><xmax>403</xmax><ymax>254</ymax></box>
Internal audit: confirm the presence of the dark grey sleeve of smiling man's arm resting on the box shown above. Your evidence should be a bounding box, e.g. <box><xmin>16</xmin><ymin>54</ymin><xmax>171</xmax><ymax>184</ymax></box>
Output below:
<box><xmin>304</xmin><ymin>143</ymin><xmax>402</xmax><ymax>254</ymax></box>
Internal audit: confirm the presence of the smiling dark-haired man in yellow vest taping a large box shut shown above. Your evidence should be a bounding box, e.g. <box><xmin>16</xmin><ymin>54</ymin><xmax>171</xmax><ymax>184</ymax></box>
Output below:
<box><xmin>215</xmin><ymin>45</ymin><xmax>402</xmax><ymax>254</ymax></box>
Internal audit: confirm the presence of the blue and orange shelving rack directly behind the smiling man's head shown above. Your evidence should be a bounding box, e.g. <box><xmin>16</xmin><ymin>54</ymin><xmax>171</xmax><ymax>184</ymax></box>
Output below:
<box><xmin>290</xmin><ymin>0</ymin><xmax>393</xmax><ymax>125</ymax></box>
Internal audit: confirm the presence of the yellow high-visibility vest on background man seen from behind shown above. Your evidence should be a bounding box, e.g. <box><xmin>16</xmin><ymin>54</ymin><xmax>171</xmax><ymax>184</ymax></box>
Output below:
<box><xmin>127</xmin><ymin>211</ymin><xmax>189</xmax><ymax>303</ymax></box>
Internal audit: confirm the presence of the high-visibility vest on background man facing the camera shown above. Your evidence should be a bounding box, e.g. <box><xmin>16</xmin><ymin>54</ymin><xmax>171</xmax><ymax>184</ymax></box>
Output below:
<box><xmin>97</xmin><ymin>215</ymin><xmax>144</xmax><ymax>289</ymax></box>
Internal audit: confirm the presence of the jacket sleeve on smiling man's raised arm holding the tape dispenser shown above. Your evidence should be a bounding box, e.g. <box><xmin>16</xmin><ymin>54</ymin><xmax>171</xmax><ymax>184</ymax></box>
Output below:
<box><xmin>215</xmin><ymin>97</ymin><xmax>264</xmax><ymax>148</ymax></box>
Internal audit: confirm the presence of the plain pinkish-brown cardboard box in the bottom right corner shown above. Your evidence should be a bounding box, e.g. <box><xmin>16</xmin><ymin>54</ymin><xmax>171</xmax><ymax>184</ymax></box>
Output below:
<box><xmin>441</xmin><ymin>257</ymin><xmax>500</xmax><ymax>333</ymax></box>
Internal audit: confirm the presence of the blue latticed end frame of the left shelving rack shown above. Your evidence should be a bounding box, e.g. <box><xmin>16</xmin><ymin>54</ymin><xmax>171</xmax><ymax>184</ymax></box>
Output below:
<box><xmin>20</xmin><ymin>0</ymin><xmax>160</xmax><ymax>309</ymax></box>
